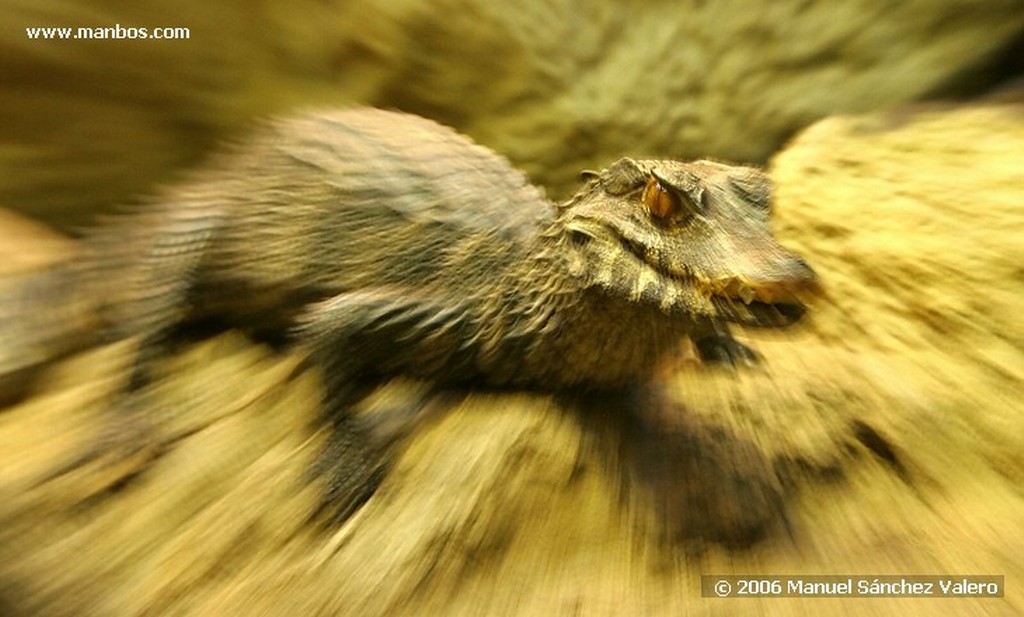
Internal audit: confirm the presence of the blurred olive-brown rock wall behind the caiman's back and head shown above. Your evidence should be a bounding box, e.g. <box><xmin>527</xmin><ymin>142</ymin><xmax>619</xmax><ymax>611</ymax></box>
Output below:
<box><xmin>0</xmin><ymin>0</ymin><xmax>1024</xmax><ymax>228</ymax></box>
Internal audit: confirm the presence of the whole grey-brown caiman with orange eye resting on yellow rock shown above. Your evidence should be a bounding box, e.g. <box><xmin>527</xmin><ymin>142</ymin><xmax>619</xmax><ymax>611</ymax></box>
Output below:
<box><xmin>0</xmin><ymin>108</ymin><xmax>818</xmax><ymax>519</ymax></box>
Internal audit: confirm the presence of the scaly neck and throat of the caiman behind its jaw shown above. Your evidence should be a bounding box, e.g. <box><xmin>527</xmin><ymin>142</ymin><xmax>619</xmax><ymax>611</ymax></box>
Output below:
<box><xmin>480</xmin><ymin>221</ymin><xmax>692</xmax><ymax>388</ymax></box>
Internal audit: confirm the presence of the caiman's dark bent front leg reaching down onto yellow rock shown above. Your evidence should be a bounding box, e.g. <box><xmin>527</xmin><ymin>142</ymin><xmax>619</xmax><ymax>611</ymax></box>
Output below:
<box><xmin>295</xmin><ymin>289</ymin><xmax>466</xmax><ymax>522</ymax></box>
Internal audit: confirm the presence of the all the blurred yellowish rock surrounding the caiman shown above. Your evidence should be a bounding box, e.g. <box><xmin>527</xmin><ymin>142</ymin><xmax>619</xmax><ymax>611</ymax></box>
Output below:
<box><xmin>0</xmin><ymin>0</ymin><xmax>1024</xmax><ymax>615</ymax></box>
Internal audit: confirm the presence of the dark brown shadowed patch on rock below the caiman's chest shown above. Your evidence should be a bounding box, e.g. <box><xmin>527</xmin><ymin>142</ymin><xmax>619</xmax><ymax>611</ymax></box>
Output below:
<box><xmin>565</xmin><ymin>389</ymin><xmax>787</xmax><ymax>548</ymax></box>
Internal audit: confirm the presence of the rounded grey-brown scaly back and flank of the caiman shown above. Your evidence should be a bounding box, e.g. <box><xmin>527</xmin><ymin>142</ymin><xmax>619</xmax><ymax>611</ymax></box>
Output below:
<box><xmin>92</xmin><ymin>109</ymin><xmax>555</xmax><ymax>335</ymax></box>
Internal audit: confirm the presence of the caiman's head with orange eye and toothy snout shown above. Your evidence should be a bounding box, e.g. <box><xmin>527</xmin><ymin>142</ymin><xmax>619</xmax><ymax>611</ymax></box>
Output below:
<box><xmin>554</xmin><ymin>159</ymin><xmax>819</xmax><ymax>325</ymax></box>
